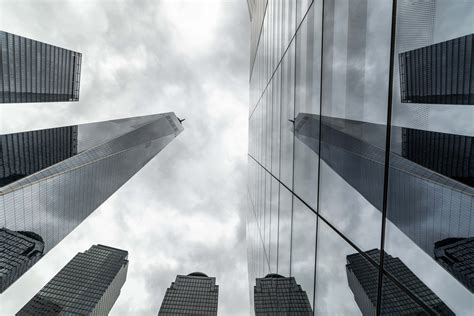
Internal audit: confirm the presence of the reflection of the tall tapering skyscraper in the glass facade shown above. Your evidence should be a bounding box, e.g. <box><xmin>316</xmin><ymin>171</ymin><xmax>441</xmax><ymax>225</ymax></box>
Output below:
<box><xmin>295</xmin><ymin>113</ymin><xmax>474</xmax><ymax>276</ymax></box>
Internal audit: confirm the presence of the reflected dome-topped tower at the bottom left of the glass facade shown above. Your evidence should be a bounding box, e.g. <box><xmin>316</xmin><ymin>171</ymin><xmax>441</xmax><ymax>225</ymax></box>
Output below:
<box><xmin>254</xmin><ymin>274</ymin><xmax>313</xmax><ymax>316</ymax></box>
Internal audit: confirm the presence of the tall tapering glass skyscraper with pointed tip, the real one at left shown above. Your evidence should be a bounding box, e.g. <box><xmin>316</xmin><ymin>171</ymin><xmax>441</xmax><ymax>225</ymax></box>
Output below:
<box><xmin>0</xmin><ymin>113</ymin><xmax>183</xmax><ymax>292</ymax></box>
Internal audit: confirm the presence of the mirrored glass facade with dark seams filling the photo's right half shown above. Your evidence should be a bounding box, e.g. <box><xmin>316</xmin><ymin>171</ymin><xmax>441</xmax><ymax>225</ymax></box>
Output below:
<box><xmin>246</xmin><ymin>0</ymin><xmax>474</xmax><ymax>315</ymax></box>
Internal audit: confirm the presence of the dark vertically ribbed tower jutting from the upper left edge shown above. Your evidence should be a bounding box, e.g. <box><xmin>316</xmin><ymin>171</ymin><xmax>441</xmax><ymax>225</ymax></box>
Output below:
<box><xmin>0</xmin><ymin>31</ymin><xmax>82</xmax><ymax>103</ymax></box>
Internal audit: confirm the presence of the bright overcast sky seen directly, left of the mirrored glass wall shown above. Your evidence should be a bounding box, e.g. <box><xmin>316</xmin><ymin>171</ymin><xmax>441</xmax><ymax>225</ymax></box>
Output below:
<box><xmin>0</xmin><ymin>0</ymin><xmax>249</xmax><ymax>316</ymax></box>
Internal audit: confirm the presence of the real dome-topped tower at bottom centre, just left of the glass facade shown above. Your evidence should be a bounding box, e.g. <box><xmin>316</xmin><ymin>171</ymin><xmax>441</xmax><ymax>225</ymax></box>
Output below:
<box><xmin>158</xmin><ymin>272</ymin><xmax>219</xmax><ymax>316</ymax></box>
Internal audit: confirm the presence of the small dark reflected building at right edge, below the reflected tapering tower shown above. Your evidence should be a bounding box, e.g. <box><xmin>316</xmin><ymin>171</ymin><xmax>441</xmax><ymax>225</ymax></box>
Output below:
<box><xmin>434</xmin><ymin>237</ymin><xmax>474</xmax><ymax>293</ymax></box>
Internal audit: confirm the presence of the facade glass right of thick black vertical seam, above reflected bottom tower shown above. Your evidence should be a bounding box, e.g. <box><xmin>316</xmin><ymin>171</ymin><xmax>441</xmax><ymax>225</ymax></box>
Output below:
<box><xmin>385</xmin><ymin>0</ymin><xmax>474</xmax><ymax>298</ymax></box>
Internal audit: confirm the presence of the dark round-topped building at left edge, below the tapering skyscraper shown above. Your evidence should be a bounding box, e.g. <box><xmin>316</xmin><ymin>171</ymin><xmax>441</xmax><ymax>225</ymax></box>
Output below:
<box><xmin>0</xmin><ymin>228</ymin><xmax>44</xmax><ymax>293</ymax></box>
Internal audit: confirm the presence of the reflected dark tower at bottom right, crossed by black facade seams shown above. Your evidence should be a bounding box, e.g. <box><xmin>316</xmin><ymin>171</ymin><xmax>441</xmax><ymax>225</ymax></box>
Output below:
<box><xmin>346</xmin><ymin>249</ymin><xmax>455</xmax><ymax>315</ymax></box>
